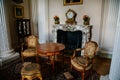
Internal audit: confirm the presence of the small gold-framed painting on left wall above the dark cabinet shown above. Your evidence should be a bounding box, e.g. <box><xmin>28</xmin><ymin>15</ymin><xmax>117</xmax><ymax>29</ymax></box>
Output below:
<box><xmin>14</xmin><ymin>6</ymin><xmax>24</xmax><ymax>18</ymax></box>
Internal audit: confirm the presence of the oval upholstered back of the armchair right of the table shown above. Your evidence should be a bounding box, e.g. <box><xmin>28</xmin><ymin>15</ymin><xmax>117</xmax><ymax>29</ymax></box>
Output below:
<box><xmin>84</xmin><ymin>41</ymin><xmax>98</xmax><ymax>59</ymax></box>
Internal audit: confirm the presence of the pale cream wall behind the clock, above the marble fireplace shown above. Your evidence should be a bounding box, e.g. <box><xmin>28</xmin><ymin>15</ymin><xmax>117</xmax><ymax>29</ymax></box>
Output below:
<box><xmin>49</xmin><ymin>0</ymin><xmax>102</xmax><ymax>42</ymax></box>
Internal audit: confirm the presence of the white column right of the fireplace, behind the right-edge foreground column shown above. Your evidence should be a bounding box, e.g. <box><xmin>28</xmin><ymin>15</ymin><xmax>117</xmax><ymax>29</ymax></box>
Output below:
<box><xmin>100</xmin><ymin>0</ymin><xmax>119</xmax><ymax>54</ymax></box>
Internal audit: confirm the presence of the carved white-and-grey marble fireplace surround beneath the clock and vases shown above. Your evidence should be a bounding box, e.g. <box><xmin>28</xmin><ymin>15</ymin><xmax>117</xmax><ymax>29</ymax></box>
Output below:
<box><xmin>52</xmin><ymin>24</ymin><xmax>92</xmax><ymax>47</ymax></box>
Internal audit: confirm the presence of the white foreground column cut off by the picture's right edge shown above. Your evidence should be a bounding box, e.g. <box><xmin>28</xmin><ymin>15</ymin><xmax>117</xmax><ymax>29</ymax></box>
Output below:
<box><xmin>109</xmin><ymin>0</ymin><xmax>120</xmax><ymax>80</ymax></box>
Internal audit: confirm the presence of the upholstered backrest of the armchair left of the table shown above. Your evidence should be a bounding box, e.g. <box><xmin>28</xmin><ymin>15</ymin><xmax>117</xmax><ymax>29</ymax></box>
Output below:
<box><xmin>26</xmin><ymin>35</ymin><xmax>38</xmax><ymax>48</ymax></box>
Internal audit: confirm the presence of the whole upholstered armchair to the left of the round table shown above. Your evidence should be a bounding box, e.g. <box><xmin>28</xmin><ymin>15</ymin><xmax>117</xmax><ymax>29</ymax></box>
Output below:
<box><xmin>21</xmin><ymin>35</ymin><xmax>38</xmax><ymax>62</ymax></box>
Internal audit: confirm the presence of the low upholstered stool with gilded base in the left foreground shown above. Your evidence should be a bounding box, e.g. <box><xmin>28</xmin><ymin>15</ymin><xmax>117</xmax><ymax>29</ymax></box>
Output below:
<box><xmin>21</xmin><ymin>62</ymin><xmax>42</xmax><ymax>80</ymax></box>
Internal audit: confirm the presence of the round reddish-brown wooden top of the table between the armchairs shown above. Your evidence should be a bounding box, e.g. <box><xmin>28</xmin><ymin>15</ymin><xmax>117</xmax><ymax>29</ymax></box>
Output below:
<box><xmin>37</xmin><ymin>42</ymin><xmax>65</xmax><ymax>54</ymax></box>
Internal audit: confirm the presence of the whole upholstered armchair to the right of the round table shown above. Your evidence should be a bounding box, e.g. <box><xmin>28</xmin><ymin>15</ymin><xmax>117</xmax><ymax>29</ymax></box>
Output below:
<box><xmin>71</xmin><ymin>41</ymin><xmax>98</xmax><ymax>80</ymax></box>
